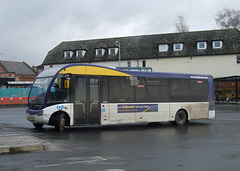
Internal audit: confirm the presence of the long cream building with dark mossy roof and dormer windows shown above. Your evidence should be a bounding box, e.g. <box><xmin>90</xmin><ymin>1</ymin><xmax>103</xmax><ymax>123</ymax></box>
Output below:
<box><xmin>43</xmin><ymin>29</ymin><xmax>240</xmax><ymax>102</ymax></box>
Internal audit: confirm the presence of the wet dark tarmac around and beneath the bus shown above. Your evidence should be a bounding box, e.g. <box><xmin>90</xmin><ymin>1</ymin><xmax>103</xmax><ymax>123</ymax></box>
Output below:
<box><xmin>0</xmin><ymin>104</ymin><xmax>240</xmax><ymax>170</ymax></box>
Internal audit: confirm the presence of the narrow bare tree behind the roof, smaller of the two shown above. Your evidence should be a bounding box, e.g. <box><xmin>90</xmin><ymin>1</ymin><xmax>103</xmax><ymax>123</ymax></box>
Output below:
<box><xmin>175</xmin><ymin>12</ymin><xmax>189</xmax><ymax>33</ymax></box>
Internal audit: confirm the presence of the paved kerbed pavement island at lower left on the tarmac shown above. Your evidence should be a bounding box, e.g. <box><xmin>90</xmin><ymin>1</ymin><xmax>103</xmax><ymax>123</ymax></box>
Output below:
<box><xmin>0</xmin><ymin>124</ymin><xmax>50</xmax><ymax>154</ymax></box>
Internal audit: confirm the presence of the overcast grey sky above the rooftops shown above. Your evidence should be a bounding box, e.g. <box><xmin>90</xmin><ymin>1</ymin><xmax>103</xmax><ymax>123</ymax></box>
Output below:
<box><xmin>0</xmin><ymin>0</ymin><xmax>240</xmax><ymax>66</ymax></box>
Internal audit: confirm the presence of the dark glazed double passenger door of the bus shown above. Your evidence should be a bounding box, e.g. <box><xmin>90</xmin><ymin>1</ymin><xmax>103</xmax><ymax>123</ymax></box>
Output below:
<box><xmin>74</xmin><ymin>77</ymin><xmax>100</xmax><ymax>124</ymax></box>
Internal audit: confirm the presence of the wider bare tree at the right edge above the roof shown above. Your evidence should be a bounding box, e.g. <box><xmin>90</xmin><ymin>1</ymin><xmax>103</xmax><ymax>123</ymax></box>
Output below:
<box><xmin>215</xmin><ymin>8</ymin><xmax>240</xmax><ymax>29</ymax></box>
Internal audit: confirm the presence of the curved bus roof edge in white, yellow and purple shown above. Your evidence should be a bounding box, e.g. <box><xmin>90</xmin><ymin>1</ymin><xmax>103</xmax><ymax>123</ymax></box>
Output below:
<box><xmin>37</xmin><ymin>64</ymin><xmax>212</xmax><ymax>79</ymax></box>
